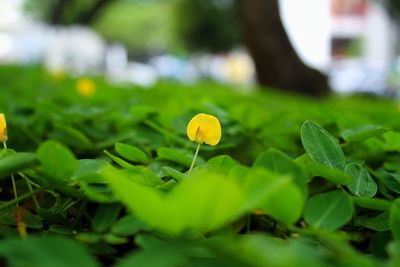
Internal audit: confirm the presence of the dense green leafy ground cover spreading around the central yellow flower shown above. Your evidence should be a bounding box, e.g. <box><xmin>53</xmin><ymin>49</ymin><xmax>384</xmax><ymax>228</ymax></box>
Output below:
<box><xmin>0</xmin><ymin>67</ymin><xmax>400</xmax><ymax>267</ymax></box>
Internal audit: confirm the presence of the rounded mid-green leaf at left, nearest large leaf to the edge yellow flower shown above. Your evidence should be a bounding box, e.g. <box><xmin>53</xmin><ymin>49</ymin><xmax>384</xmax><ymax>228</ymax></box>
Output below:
<box><xmin>37</xmin><ymin>140</ymin><xmax>78</xmax><ymax>181</ymax></box>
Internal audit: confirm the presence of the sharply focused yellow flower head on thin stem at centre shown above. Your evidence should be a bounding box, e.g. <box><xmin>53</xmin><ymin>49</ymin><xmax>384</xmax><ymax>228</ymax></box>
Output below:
<box><xmin>186</xmin><ymin>113</ymin><xmax>221</xmax><ymax>146</ymax></box>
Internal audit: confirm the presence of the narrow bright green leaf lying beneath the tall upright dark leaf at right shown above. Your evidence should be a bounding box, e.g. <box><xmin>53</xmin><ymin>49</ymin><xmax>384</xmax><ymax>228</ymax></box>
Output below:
<box><xmin>295</xmin><ymin>153</ymin><xmax>352</xmax><ymax>185</ymax></box>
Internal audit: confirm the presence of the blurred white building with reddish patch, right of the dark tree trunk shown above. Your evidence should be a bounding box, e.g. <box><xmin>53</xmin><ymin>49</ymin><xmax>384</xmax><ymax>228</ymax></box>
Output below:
<box><xmin>280</xmin><ymin>0</ymin><xmax>397</xmax><ymax>92</ymax></box>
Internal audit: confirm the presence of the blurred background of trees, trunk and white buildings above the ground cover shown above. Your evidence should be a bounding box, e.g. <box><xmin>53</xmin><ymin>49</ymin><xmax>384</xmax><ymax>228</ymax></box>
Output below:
<box><xmin>0</xmin><ymin>0</ymin><xmax>400</xmax><ymax>96</ymax></box>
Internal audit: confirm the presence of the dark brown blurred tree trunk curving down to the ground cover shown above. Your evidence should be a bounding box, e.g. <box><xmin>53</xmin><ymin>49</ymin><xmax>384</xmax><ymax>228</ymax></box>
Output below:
<box><xmin>239</xmin><ymin>0</ymin><xmax>329</xmax><ymax>96</ymax></box>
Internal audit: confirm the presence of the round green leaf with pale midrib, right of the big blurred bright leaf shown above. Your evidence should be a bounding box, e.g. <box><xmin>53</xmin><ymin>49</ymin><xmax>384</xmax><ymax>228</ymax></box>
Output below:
<box><xmin>304</xmin><ymin>191</ymin><xmax>354</xmax><ymax>230</ymax></box>
